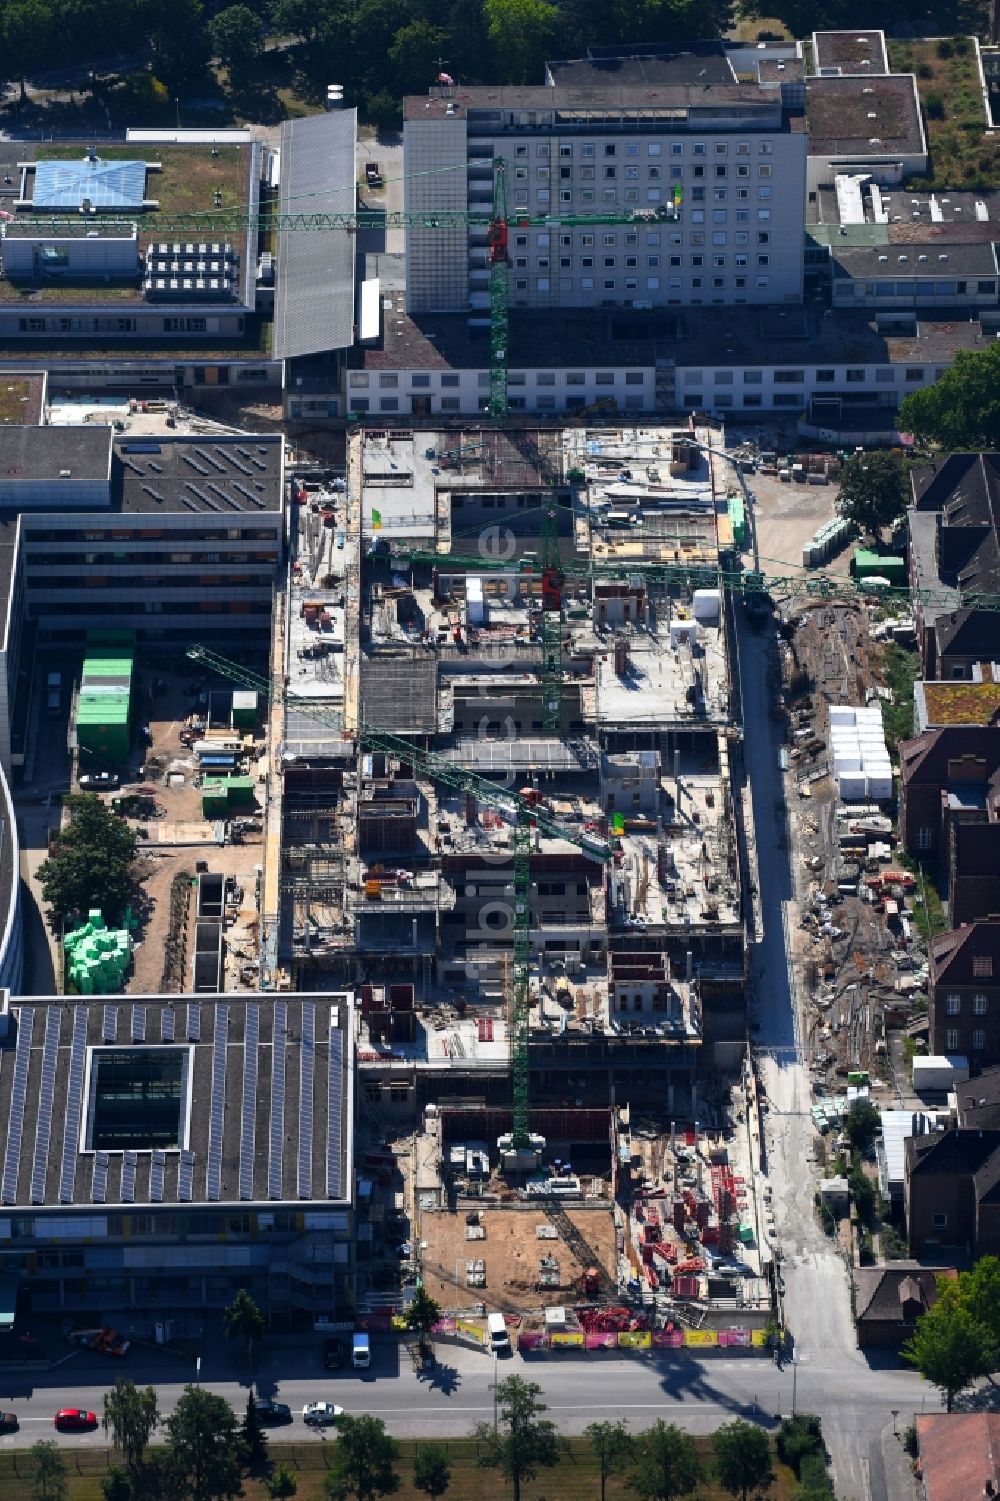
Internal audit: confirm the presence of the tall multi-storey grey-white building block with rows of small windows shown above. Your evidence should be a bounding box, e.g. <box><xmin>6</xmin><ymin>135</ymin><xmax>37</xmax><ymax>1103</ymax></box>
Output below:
<box><xmin>404</xmin><ymin>84</ymin><xmax>806</xmax><ymax>315</ymax></box>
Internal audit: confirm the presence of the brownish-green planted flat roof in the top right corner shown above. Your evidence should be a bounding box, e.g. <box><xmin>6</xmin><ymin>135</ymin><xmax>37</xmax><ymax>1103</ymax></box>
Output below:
<box><xmin>887</xmin><ymin>36</ymin><xmax>1000</xmax><ymax>189</ymax></box>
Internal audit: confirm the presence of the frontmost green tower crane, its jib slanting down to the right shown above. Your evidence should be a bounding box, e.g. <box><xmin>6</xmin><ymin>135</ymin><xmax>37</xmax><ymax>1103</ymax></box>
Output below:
<box><xmin>188</xmin><ymin>645</ymin><xmax>613</xmax><ymax>1148</ymax></box>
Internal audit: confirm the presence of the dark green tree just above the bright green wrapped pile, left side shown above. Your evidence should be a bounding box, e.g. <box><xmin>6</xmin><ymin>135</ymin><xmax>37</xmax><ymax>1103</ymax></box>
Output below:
<box><xmin>38</xmin><ymin>793</ymin><xmax>137</xmax><ymax>923</ymax></box>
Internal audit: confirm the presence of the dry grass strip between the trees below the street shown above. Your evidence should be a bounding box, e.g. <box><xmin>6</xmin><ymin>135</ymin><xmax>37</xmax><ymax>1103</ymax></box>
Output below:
<box><xmin>0</xmin><ymin>1436</ymin><xmax>797</xmax><ymax>1501</ymax></box>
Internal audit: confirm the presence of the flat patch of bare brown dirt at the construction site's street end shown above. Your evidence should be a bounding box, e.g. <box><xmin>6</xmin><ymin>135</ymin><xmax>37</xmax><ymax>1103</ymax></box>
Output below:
<box><xmin>420</xmin><ymin>1202</ymin><xmax>616</xmax><ymax>1313</ymax></box>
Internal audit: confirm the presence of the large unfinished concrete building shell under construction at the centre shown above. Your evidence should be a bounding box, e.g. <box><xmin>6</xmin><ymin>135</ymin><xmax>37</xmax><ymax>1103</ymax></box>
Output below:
<box><xmin>179</xmin><ymin>425</ymin><xmax>760</xmax><ymax>1328</ymax></box>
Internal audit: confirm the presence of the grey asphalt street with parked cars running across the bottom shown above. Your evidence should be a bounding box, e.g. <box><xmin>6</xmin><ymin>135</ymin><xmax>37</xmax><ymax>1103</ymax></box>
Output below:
<box><xmin>0</xmin><ymin>1339</ymin><xmax>920</xmax><ymax>1452</ymax></box>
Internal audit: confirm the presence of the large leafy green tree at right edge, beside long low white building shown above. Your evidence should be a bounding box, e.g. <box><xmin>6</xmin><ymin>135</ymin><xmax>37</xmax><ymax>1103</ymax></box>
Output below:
<box><xmin>898</xmin><ymin>342</ymin><xmax>1000</xmax><ymax>450</ymax></box>
